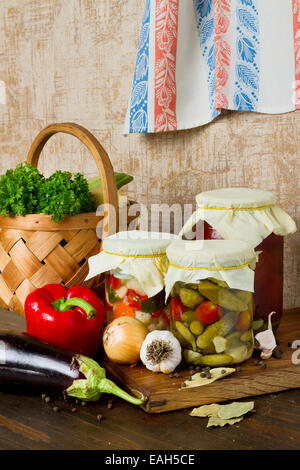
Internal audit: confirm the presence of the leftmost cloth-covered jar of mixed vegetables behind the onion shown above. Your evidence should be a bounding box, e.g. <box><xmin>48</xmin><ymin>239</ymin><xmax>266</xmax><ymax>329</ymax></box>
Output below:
<box><xmin>87</xmin><ymin>230</ymin><xmax>176</xmax><ymax>331</ymax></box>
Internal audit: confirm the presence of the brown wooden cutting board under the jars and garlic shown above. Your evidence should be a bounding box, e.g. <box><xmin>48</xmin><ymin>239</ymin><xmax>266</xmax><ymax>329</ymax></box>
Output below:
<box><xmin>103</xmin><ymin>308</ymin><xmax>300</xmax><ymax>413</ymax></box>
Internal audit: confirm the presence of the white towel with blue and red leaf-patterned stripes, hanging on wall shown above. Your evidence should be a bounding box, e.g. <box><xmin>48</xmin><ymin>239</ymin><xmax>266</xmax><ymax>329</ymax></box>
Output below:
<box><xmin>125</xmin><ymin>0</ymin><xmax>300</xmax><ymax>134</ymax></box>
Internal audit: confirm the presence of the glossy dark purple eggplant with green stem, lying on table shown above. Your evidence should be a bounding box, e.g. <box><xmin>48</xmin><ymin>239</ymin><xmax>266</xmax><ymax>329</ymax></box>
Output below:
<box><xmin>0</xmin><ymin>330</ymin><xmax>143</xmax><ymax>405</ymax></box>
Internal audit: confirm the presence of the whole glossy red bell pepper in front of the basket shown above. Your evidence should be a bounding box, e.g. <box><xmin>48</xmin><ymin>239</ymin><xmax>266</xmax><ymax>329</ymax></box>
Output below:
<box><xmin>24</xmin><ymin>284</ymin><xmax>105</xmax><ymax>357</ymax></box>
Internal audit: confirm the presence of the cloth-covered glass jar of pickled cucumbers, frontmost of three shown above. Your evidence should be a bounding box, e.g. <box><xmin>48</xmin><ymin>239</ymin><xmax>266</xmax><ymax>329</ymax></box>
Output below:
<box><xmin>165</xmin><ymin>240</ymin><xmax>256</xmax><ymax>367</ymax></box>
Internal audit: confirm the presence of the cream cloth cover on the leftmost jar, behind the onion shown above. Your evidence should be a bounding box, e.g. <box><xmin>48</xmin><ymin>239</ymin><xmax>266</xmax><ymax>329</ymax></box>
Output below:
<box><xmin>86</xmin><ymin>230</ymin><xmax>177</xmax><ymax>297</ymax></box>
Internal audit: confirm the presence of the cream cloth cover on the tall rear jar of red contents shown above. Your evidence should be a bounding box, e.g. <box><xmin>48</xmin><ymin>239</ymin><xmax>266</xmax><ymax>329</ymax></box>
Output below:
<box><xmin>179</xmin><ymin>188</ymin><xmax>297</xmax><ymax>248</ymax></box>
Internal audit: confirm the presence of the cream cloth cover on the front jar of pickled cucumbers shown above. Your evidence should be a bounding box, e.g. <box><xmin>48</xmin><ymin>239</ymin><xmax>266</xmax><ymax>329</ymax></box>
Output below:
<box><xmin>165</xmin><ymin>240</ymin><xmax>257</xmax><ymax>297</ymax></box>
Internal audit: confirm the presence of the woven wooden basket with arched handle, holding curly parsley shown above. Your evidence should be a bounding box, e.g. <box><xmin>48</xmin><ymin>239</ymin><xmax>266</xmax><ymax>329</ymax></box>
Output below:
<box><xmin>0</xmin><ymin>123</ymin><xmax>125</xmax><ymax>315</ymax></box>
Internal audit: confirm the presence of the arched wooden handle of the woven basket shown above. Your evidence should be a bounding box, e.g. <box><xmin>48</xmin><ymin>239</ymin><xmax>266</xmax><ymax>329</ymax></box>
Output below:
<box><xmin>27</xmin><ymin>122</ymin><xmax>118</xmax><ymax>238</ymax></box>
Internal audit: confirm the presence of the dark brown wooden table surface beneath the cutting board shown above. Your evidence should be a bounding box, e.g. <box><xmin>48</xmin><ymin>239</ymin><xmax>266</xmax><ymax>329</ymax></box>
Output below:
<box><xmin>0</xmin><ymin>310</ymin><xmax>300</xmax><ymax>450</ymax></box>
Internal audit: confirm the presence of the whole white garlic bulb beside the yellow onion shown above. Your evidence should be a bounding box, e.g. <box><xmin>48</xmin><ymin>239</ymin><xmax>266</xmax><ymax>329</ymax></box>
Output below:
<box><xmin>140</xmin><ymin>330</ymin><xmax>181</xmax><ymax>374</ymax></box>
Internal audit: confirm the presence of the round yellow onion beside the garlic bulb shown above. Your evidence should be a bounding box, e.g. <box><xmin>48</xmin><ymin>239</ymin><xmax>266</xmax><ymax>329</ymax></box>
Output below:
<box><xmin>103</xmin><ymin>316</ymin><xmax>148</xmax><ymax>364</ymax></box>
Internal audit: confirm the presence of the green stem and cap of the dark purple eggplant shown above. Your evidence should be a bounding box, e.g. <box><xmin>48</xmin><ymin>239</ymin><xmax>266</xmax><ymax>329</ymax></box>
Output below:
<box><xmin>65</xmin><ymin>355</ymin><xmax>144</xmax><ymax>405</ymax></box>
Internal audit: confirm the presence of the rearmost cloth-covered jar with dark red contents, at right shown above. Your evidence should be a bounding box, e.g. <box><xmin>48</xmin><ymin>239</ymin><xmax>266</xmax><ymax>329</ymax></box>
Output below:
<box><xmin>179</xmin><ymin>188</ymin><xmax>296</xmax><ymax>330</ymax></box>
